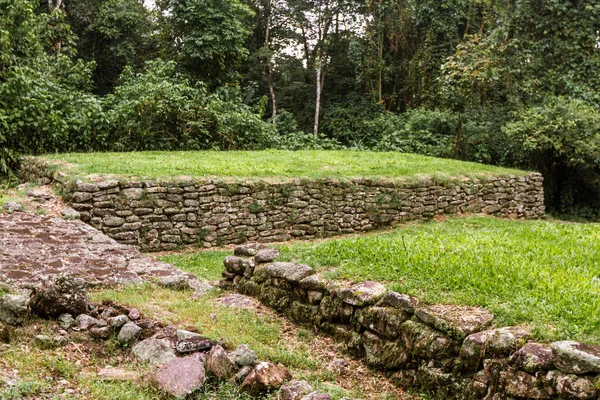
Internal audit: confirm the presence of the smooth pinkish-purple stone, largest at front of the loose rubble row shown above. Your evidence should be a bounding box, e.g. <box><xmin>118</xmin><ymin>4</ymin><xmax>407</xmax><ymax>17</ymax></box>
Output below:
<box><xmin>154</xmin><ymin>356</ymin><xmax>206</xmax><ymax>399</ymax></box>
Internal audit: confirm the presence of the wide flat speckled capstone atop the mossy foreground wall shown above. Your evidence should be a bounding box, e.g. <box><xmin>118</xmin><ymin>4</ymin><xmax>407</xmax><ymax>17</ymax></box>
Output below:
<box><xmin>415</xmin><ymin>305</ymin><xmax>494</xmax><ymax>340</ymax></box>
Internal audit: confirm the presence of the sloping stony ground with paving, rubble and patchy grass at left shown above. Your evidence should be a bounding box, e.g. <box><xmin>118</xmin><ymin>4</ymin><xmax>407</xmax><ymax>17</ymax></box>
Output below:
<box><xmin>0</xmin><ymin>187</ymin><xmax>408</xmax><ymax>400</ymax></box>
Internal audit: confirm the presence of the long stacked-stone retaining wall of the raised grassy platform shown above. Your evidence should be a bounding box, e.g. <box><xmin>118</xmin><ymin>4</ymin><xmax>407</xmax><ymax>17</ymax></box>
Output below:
<box><xmin>21</xmin><ymin>157</ymin><xmax>545</xmax><ymax>251</ymax></box>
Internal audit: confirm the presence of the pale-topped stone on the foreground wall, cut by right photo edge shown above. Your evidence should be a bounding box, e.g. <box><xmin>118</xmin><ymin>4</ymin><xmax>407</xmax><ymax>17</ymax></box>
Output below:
<box><xmin>552</xmin><ymin>340</ymin><xmax>600</xmax><ymax>374</ymax></box>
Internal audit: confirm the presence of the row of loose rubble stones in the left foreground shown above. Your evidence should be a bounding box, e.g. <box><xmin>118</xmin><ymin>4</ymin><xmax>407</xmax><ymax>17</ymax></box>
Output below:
<box><xmin>0</xmin><ymin>275</ymin><xmax>338</xmax><ymax>400</ymax></box>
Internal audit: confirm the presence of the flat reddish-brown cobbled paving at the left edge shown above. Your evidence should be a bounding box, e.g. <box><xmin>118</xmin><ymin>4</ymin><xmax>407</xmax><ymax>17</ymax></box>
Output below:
<box><xmin>0</xmin><ymin>213</ymin><xmax>192</xmax><ymax>290</ymax></box>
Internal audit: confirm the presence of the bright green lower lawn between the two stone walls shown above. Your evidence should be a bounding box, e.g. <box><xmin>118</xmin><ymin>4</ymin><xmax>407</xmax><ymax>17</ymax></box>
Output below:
<box><xmin>159</xmin><ymin>217</ymin><xmax>600</xmax><ymax>343</ymax></box>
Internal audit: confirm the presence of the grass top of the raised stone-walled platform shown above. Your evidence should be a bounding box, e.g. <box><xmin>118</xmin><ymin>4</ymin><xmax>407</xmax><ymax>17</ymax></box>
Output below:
<box><xmin>46</xmin><ymin>150</ymin><xmax>525</xmax><ymax>181</ymax></box>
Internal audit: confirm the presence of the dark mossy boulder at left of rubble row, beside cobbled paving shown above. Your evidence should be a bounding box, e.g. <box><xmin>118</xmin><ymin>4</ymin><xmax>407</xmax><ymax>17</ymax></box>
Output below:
<box><xmin>31</xmin><ymin>275</ymin><xmax>89</xmax><ymax>318</ymax></box>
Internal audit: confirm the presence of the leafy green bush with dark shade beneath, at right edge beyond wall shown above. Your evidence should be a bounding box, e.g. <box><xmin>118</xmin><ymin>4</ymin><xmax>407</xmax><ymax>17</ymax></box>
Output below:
<box><xmin>504</xmin><ymin>97</ymin><xmax>600</xmax><ymax>212</ymax></box>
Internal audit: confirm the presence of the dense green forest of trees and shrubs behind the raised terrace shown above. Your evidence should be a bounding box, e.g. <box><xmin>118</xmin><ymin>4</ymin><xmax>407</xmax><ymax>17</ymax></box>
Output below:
<box><xmin>0</xmin><ymin>0</ymin><xmax>600</xmax><ymax>215</ymax></box>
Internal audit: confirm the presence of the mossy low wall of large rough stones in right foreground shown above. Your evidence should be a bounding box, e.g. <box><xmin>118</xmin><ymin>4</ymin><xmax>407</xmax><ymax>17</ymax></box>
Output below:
<box><xmin>221</xmin><ymin>245</ymin><xmax>600</xmax><ymax>400</ymax></box>
